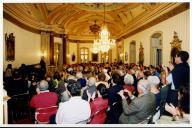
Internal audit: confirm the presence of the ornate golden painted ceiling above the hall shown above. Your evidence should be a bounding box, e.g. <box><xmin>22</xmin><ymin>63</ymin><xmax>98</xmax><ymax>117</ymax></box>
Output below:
<box><xmin>3</xmin><ymin>3</ymin><xmax>189</xmax><ymax>40</ymax></box>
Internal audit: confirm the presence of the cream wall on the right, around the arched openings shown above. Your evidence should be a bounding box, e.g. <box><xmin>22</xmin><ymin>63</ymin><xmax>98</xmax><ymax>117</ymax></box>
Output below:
<box><xmin>124</xmin><ymin>10</ymin><xmax>190</xmax><ymax>65</ymax></box>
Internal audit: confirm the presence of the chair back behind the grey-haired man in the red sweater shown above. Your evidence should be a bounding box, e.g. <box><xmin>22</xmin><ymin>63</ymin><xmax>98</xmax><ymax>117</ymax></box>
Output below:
<box><xmin>35</xmin><ymin>106</ymin><xmax>58</xmax><ymax>123</ymax></box>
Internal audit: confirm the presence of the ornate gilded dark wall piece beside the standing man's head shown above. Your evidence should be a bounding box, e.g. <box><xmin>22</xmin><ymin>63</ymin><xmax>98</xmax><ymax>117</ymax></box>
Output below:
<box><xmin>170</xmin><ymin>31</ymin><xmax>182</xmax><ymax>65</ymax></box>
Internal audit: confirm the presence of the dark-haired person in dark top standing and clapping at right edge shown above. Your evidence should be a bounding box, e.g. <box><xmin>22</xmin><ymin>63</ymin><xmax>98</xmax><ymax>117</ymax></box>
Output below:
<box><xmin>164</xmin><ymin>51</ymin><xmax>190</xmax><ymax>107</ymax></box>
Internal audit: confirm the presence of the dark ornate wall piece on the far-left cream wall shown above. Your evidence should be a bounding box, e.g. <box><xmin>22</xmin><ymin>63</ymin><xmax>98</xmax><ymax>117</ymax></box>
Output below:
<box><xmin>5</xmin><ymin>33</ymin><xmax>15</xmax><ymax>61</ymax></box>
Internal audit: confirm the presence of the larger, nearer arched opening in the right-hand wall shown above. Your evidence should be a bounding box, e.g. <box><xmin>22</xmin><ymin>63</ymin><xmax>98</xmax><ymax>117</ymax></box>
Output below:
<box><xmin>150</xmin><ymin>32</ymin><xmax>162</xmax><ymax>66</ymax></box>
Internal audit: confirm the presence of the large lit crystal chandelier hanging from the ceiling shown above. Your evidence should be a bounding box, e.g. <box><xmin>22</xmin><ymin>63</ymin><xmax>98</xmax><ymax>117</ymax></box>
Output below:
<box><xmin>91</xmin><ymin>4</ymin><xmax>115</xmax><ymax>53</ymax></box>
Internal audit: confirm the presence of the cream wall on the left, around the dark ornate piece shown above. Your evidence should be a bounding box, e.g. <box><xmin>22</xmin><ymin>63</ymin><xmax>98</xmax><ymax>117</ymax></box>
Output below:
<box><xmin>3</xmin><ymin>19</ymin><xmax>41</xmax><ymax>70</ymax></box>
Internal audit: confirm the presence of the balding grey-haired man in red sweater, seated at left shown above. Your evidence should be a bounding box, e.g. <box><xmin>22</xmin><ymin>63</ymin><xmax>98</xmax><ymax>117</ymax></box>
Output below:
<box><xmin>30</xmin><ymin>80</ymin><xmax>58</xmax><ymax>108</ymax></box>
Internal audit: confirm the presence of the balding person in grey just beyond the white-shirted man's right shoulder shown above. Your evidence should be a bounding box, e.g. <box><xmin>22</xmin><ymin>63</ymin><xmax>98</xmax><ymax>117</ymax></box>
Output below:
<box><xmin>82</xmin><ymin>77</ymin><xmax>97</xmax><ymax>100</ymax></box>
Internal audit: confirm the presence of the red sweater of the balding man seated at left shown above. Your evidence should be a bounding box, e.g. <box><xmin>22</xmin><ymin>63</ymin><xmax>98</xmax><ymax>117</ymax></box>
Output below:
<box><xmin>30</xmin><ymin>92</ymin><xmax>58</xmax><ymax>108</ymax></box>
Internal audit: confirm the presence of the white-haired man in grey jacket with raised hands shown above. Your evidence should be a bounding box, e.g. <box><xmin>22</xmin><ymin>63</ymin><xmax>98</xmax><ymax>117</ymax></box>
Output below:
<box><xmin>118</xmin><ymin>80</ymin><xmax>156</xmax><ymax>124</ymax></box>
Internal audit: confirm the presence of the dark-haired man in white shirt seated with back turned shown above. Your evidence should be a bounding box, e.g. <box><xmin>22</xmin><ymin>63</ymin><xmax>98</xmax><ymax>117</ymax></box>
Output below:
<box><xmin>56</xmin><ymin>80</ymin><xmax>91</xmax><ymax>124</ymax></box>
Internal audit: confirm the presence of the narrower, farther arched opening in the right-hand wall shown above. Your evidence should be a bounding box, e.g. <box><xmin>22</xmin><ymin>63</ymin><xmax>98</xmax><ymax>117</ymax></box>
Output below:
<box><xmin>129</xmin><ymin>41</ymin><xmax>136</xmax><ymax>63</ymax></box>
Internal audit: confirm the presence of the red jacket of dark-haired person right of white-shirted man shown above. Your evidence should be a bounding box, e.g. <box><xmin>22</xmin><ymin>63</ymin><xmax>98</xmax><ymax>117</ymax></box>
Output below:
<box><xmin>90</xmin><ymin>97</ymin><xmax>108</xmax><ymax>124</ymax></box>
